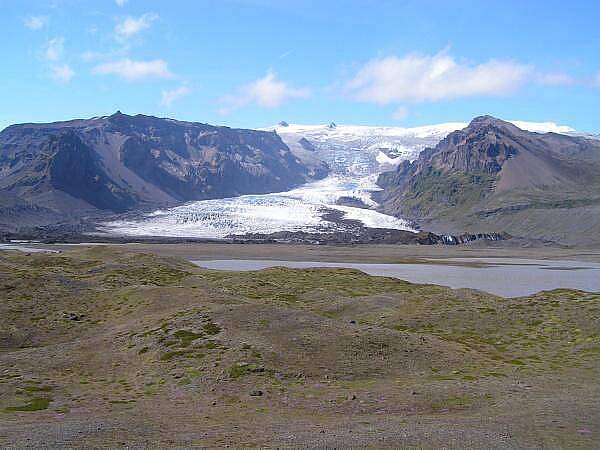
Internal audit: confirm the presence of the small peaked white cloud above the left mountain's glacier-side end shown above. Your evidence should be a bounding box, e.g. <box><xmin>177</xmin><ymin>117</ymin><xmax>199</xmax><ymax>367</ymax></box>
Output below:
<box><xmin>219</xmin><ymin>71</ymin><xmax>311</xmax><ymax>114</ymax></box>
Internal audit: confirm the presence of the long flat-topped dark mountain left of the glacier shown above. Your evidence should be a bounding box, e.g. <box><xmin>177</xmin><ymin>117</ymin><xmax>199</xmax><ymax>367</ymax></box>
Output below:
<box><xmin>0</xmin><ymin>112</ymin><xmax>328</xmax><ymax>230</ymax></box>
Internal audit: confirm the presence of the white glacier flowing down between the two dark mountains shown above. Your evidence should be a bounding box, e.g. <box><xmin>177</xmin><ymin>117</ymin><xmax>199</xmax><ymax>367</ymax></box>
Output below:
<box><xmin>101</xmin><ymin>121</ymin><xmax>575</xmax><ymax>239</ymax></box>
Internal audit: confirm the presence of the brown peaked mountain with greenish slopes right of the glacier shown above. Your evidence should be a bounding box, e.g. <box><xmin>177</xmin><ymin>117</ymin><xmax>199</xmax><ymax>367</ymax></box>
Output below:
<box><xmin>377</xmin><ymin>116</ymin><xmax>600</xmax><ymax>243</ymax></box>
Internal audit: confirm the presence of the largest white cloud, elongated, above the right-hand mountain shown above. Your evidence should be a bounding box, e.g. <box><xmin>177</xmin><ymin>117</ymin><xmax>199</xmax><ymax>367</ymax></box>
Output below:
<box><xmin>347</xmin><ymin>52</ymin><xmax>532</xmax><ymax>104</ymax></box>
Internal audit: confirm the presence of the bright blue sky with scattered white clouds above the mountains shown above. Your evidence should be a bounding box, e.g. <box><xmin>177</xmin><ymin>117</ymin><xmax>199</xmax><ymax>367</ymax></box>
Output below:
<box><xmin>0</xmin><ymin>0</ymin><xmax>600</xmax><ymax>133</ymax></box>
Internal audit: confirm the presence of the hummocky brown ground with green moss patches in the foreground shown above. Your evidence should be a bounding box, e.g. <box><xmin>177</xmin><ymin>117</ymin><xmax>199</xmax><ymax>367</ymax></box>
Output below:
<box><xmin>0</xmin><ymin>247</ymin><xmax>600</xmax><ymax>448</ymax></box>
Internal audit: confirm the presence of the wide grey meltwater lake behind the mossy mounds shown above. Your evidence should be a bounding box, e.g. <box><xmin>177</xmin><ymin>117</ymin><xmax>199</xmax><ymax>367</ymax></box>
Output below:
<box><xmin>193</xmin><ymin>258</ymin><xmax>600</xmax><ymax>297</ymax></box>
